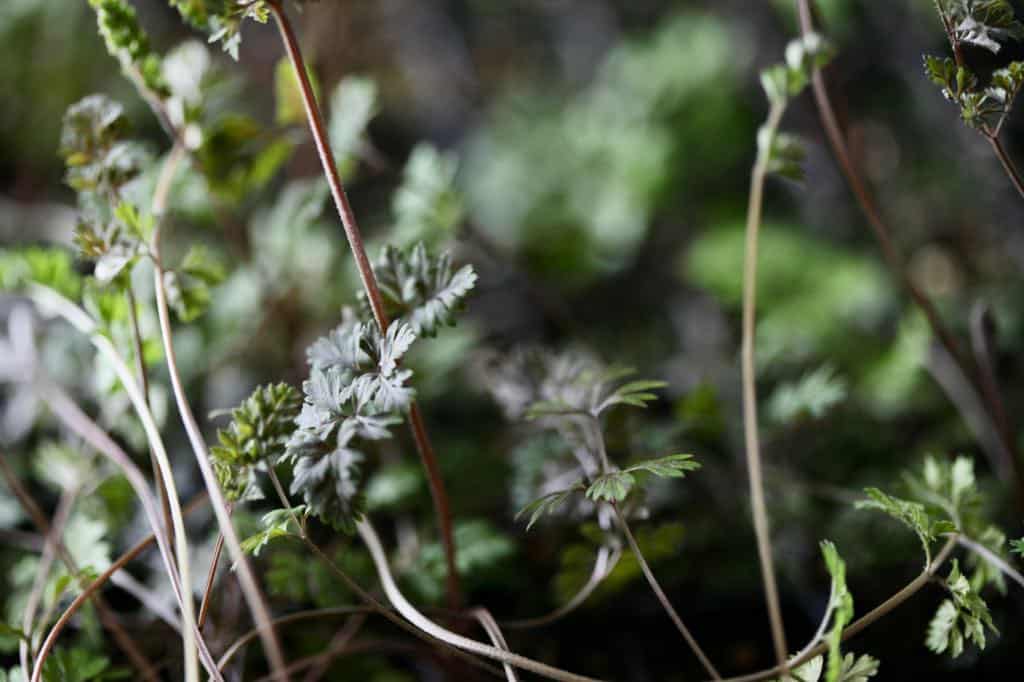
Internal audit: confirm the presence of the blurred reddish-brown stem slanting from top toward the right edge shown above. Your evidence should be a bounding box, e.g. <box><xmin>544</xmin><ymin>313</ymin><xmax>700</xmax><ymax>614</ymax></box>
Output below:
<box><xmin>796</xmin><ymin>0</ymin><xmax>1024</xmax><ymax>506</ymax></box>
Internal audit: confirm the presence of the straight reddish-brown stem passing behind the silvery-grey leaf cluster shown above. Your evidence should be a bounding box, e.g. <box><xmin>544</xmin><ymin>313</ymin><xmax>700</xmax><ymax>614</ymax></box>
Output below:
<box><xmin>267</xmin><ymin>0</ymin><xmax>462</xmax><ymax>609</ymax></box>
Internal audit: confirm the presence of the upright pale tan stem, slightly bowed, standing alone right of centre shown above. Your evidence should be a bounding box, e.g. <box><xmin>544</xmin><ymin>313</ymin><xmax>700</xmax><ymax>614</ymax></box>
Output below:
<box><xmin>741</xmin><ymin>102</ymin><xmax>787</xmax><ymax>667</ymax></box>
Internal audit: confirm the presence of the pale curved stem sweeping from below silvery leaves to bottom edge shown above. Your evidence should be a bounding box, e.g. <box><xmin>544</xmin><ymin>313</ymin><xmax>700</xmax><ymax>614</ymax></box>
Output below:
<box><xmin>355</xmin><ymin>518</ymin><xmax>595</xmax><ymax>682</ymax></box>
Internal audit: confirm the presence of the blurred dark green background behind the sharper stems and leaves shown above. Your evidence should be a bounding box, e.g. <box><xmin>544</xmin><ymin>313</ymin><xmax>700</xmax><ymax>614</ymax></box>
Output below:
<box><xmin>0</xmin><ymin>0</ymin><xmax>1024</xmax><ymax>681</ymax></box>
